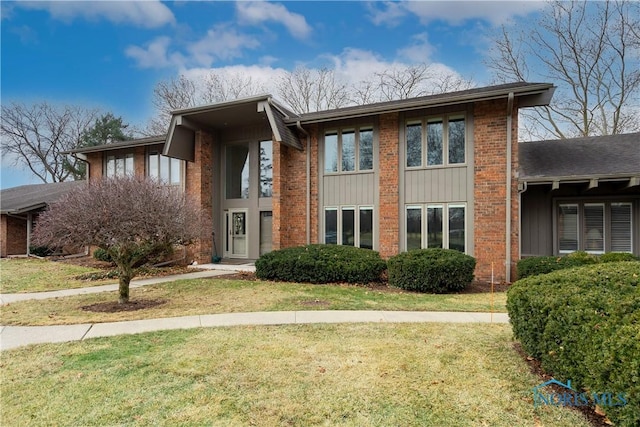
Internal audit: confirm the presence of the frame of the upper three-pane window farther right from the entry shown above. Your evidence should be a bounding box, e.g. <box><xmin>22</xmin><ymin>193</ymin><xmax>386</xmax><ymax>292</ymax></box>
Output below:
<box><xmin>404</xmin><ymin>112</ymin><xmax>469</xmax><ymax>170</ymax></box>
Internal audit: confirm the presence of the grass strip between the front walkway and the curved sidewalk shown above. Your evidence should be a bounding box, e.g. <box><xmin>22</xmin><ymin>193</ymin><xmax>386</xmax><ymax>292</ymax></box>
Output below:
<box><xmin>0</xmin><ymin>278</ymin><xmax>506</xmax><ymax>325</ymax></box>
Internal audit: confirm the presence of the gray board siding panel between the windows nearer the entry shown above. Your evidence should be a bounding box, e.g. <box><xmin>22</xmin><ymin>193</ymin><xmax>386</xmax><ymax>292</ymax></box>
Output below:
<box><xmin>322</xmin><ymin>172</ymin><xmax>376</xmax><ymax>206</ymax></box>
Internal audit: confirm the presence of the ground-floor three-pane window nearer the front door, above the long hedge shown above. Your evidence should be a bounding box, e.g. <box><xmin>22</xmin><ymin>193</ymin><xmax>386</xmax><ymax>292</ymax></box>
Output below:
<box><xmin>324</xmin><ymin>206</ymin><xmax>374</xmax><ymax>249</ymax></box>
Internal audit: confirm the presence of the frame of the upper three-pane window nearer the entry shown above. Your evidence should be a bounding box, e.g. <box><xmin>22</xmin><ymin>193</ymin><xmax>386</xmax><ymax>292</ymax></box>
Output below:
<box><xmin>322</xmin><ymin>124</ymin><xmax>376</xmax><ymax>175</ymax></box>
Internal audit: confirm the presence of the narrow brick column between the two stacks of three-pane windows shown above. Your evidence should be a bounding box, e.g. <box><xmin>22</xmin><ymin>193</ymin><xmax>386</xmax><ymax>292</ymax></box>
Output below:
<box><xmin>379</xmin><ymin>113</ymin><xmax>400</xmax><ymax>258</ymax></box>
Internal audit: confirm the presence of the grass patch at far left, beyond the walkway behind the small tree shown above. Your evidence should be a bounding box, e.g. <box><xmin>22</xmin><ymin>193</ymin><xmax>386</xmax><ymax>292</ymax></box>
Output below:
<box><xmin>0</xmin><ymin>258</ymin><xmax>117</xmax><ymax>294</ymax></box>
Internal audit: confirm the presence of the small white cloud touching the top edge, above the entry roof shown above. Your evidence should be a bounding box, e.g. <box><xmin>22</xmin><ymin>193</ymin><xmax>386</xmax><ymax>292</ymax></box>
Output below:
<box><xmin>236</xmin><ymin>1</ymin><xmax>311</xmax><ymax>39</ymax></box>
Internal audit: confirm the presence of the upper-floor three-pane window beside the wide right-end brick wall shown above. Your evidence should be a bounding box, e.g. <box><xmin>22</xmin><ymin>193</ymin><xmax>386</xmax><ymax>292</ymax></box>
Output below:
<box><xmin>405</xmin><ymin>115</ymin><xmax>466</xmax><ymax>168</ymax></box>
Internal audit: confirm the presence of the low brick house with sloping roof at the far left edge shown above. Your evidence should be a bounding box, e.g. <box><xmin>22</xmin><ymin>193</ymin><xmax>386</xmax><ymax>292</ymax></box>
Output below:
<box><xmin>0</xmin><ymin>181</ymin><xmax>85</xmax><ymax>257</ymax></box>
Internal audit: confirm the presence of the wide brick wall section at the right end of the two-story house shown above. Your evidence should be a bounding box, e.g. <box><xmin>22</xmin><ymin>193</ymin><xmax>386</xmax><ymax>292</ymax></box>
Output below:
<box><xmin>473</xmin><ymin>99</ymin><xmax>519</xmax><ymax>281</ymax></box>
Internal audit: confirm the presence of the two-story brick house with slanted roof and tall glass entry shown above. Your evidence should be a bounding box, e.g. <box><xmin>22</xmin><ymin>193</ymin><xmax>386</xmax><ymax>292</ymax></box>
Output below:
<box><xmin>73</xmin><ymin>83</ymin><xmax>554</xmax><ymax>281</ymax></box>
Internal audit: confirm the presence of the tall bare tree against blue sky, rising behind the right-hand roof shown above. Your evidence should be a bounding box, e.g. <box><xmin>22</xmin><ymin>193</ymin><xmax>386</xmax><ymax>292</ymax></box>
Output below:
<box><xmin>487</xmin><ymin>0</ymin><xmax>640</xmax><ymax>138</ymax></box>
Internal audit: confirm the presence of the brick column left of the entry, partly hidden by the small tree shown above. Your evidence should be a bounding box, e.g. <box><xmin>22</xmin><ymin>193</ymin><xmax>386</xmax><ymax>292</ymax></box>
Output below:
<box><xmin>185</xmin><ymin>131</ymin><xmax>218</xmax><ymax>264</ymax></box>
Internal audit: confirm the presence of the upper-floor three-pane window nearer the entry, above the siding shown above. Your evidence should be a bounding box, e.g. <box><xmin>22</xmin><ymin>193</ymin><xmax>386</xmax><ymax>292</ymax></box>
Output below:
<box><xmin>324</xmin><ymin>126</ymin><xmax>373</xmax><ymax>173</ymax></box>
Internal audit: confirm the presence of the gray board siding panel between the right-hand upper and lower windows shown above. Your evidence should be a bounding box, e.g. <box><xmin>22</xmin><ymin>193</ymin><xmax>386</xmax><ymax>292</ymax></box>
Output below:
<box><xmin>404</xmin><ymin>166</ymin><xmax>468</xmax><ymax>204</ymax></box>
